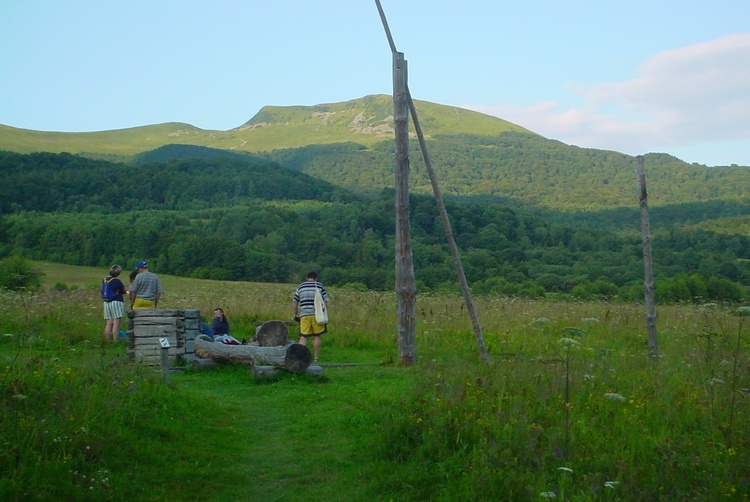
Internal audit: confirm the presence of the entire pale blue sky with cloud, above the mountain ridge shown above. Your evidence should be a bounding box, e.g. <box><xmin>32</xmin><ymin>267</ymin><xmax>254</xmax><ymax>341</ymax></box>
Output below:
<box><xmin>0</xmin><ymin>0</ymin><xmax>750</xmax><ymax>165</ymax></box>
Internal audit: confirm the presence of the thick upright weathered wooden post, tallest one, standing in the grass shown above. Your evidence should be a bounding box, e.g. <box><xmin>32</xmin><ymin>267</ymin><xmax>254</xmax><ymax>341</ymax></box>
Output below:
<box><xmin>393</xmin><ymin>52</ymin><xmax>417</xmax><ymax>366</ymax></box>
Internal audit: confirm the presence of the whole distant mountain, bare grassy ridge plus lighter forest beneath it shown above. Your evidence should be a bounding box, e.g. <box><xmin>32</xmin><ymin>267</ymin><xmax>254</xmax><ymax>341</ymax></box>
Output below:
<box><xmin>0</xmin><ymin>95</ymin><xmax>750</xmax><ymax>217</ymax></box>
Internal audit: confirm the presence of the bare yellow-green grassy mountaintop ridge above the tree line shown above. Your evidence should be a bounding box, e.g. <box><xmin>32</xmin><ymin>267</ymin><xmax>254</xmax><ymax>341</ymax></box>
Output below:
<box><xmin>0</xmin><ymin>95</ymin><xmax>528</xmax><ymax>157</ymax></box>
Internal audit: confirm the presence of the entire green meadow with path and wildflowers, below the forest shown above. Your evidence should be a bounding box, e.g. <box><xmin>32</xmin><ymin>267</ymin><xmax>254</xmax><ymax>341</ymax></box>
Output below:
<box><xmin>0</xmin><ymin>262</ymin><xmax>750</xmax><ymax>501</ymax></box>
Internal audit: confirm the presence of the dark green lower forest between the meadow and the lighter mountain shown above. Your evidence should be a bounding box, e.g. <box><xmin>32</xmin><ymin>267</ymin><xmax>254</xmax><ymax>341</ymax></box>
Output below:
<box><xmin>0</xmin><ymin>152</ymin><xmax>750</xmax><ymax>301</ymax></box>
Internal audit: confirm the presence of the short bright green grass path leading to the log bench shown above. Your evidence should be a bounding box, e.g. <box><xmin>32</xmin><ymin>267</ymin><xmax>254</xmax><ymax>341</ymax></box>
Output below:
<box><xmin>173</xmin><ymin>358</ymin><xmax>410</xmax><ymax>501</ymax></box>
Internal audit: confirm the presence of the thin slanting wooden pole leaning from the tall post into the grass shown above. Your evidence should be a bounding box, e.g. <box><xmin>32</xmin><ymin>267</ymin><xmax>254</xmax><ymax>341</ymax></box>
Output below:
<box><xmin>406</xmin><ymin>90</ymin><xmax>489</xmax><ymax>362</ymax></box>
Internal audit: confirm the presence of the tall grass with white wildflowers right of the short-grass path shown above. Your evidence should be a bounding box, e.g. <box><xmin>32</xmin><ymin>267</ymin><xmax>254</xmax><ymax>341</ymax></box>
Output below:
<box><xmin>381</xmin><ymin>302</ymin><xmax>750</xmax><ymax>501</ymax></box>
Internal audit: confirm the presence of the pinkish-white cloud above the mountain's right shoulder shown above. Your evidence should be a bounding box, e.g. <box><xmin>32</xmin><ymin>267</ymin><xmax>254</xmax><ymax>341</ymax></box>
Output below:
<box><xmin>466</xmin><ymin>33</ymin><xmax>750</xmax><ymax>162</ymax></box>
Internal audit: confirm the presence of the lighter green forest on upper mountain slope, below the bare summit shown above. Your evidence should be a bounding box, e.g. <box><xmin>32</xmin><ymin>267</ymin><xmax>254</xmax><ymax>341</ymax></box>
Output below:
<box><xmin>258</xmin><ymin>132</ymin><xmax>750</xmax><ymax>214</ymax></box>
